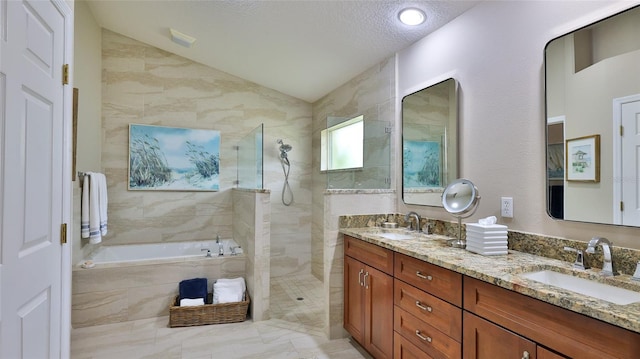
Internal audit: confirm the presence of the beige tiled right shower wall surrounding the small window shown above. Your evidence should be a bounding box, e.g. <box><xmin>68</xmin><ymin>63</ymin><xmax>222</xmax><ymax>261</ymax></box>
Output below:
<box><xmin>311</xmin><ymin>57</ymin><xmax>396</xmax><ymax>280</ymax></box>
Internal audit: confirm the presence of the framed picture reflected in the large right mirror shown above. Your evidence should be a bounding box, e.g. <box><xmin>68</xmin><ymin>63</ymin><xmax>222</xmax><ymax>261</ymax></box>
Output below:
<box><xmin>565</xmin><ymin>135</ymin><xmax>600</xmax><ymax>183</ymax></box>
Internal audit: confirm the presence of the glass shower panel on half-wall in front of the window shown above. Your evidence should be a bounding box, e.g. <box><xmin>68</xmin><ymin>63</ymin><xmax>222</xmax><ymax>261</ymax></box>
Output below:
<box><xmin>324</xmin><ymin>108</ymin><xmax>391</xmax><ymax>189</ymax></box>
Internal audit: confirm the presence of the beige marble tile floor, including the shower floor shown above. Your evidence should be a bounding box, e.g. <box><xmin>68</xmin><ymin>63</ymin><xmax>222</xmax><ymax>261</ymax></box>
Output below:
<box><xmin>71</xmin><ymin>275</ymin><xmax>371</xmax><ymax>359</ymax></box>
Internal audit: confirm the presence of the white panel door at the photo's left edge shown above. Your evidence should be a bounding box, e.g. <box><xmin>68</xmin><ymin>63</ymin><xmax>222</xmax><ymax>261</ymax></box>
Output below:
<box><xmin>0</xmin><ymin>0</ymin><xmax>67</xmax><ymax>359</ymax></box>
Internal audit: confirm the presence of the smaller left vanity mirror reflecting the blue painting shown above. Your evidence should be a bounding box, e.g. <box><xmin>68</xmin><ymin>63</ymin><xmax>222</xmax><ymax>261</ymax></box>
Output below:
<box><xmin>402</xmin><ymin>79</ymin><xmax>458</xmax><ymax>207</ymax></box>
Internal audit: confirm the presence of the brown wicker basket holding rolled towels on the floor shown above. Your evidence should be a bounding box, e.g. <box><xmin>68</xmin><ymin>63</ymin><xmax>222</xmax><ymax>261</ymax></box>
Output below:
<box><xmin>169</xmin><ymin>292</ymin><xmax>251</xmax><ymax>328</ymax></box>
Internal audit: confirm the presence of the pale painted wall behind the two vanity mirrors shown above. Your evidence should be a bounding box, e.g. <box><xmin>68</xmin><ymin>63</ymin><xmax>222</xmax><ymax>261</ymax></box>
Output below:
<box><xmin>396</xmin><ymin>1</ymin><xmax>640</xmax><ymax>248</ymax></box>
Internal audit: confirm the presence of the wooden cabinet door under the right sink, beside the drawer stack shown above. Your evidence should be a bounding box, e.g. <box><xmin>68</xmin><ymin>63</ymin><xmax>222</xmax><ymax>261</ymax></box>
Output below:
<box><xmin>462</xmin><ymin>311</ymin><xmax>536</xmax><ymax>359</ymax></box>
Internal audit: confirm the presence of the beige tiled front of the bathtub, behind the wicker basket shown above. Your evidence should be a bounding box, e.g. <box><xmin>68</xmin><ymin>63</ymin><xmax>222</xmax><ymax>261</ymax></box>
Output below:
<box><xmin>71</xmin><ymin>256</ymin><xmax>246</xmax><ymax>328</ymax></box>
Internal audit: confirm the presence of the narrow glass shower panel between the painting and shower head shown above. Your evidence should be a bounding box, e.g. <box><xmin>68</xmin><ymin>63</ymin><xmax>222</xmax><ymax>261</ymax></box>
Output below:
<box><xmin>237</xmin><ymin>124</ymin><xmax>264</xmax><ymax>189</ymax></box>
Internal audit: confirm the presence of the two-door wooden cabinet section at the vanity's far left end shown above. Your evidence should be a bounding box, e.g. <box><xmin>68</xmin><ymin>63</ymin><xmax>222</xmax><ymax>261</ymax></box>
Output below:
<box><xmin>344</xmin><ymin>236</ymin><xmax>393</xmax><ymax>359</ymax></box>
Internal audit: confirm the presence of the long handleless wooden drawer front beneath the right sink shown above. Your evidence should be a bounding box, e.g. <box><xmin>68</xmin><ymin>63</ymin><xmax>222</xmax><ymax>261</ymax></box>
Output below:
<box><xmin>464</xmin><ymin>276</ymin><xmax>640</xmax><ymax>359</ymax></box>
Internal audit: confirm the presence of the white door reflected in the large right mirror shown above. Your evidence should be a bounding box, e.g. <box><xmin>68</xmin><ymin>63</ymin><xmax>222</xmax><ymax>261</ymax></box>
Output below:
<box><xmin>620</xmin><ymin>101</ymin><xmax>640</xmax><ymax>226</ymax></box>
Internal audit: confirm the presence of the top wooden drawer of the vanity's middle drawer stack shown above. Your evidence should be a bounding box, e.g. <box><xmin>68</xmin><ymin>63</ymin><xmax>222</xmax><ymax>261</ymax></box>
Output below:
<box><xmin>394</xmin><ymin>253</ymin><xmax>462</xmax><ymax>307</ymax></box>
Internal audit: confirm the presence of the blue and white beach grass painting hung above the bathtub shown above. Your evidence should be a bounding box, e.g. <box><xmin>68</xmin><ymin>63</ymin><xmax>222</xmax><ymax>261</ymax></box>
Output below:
<box><xmin>129</xmin><ymin>124</ymin><xmax>220</xmax><ymax>191</ymax></box>
